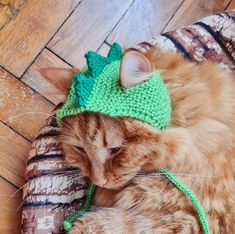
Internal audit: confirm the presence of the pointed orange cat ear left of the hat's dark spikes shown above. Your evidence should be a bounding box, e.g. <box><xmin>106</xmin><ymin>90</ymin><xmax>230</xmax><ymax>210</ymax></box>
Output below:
<box><xmin>39</xmin><ymin>68</ymin><xmax>80</xmax><ymax>94</ymax></box>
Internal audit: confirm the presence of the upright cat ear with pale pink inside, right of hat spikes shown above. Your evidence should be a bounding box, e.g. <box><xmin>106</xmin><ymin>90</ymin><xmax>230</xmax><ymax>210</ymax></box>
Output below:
<box><xmin>120</xmin><ymin>50</ymin><xmax>152</xmax><ymax>88</ymax></box>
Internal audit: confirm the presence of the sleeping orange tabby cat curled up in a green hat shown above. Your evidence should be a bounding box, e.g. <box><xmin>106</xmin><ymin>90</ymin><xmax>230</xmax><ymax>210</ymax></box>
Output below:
<box><xmin>41</xmin><ymin>49</ymin><xmax>235</xmax><ymax>234</ymax></box>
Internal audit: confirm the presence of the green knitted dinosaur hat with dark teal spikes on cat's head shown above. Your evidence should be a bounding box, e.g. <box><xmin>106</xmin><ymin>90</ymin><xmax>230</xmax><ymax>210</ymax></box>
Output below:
<box><xmin>57</xmin><ymin>43</ymin><xmax>171</xmax><ymax>130</ymax></box>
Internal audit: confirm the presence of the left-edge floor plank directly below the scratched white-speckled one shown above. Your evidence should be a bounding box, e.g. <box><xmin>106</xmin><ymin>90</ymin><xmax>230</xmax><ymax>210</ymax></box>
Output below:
<box><xmin>0</xmin><ymin>122</ymin><xmax>31</xmax><ymax>186</ymax></box>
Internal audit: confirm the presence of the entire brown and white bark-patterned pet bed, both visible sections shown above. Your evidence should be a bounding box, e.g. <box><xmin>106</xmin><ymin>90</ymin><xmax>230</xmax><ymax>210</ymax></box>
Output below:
<box><xmin>22</xmin><ymin>11</ymin><xmax>235</xmax><ymax>234</ymax></box>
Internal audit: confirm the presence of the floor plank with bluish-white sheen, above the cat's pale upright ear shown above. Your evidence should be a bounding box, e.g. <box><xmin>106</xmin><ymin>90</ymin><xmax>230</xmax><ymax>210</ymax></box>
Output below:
<box><xmin>107</xmin><ymin>0</ymin><xmax>182</xmax><ymax>47</ymax></box>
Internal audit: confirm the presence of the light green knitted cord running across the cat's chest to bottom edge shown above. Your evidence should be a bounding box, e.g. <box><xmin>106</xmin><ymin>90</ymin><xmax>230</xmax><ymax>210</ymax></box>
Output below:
<box><xmin>160</xmin><ymin>167</ymin><xmax>210</xmax><ymax>234</ymax></box>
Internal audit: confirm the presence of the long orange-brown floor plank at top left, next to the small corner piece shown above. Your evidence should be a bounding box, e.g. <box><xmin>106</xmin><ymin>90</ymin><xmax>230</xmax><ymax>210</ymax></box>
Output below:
<box><xmin>0</xmin><ymin>0</ymin><xmax>80</xmax><ymax>77</ymax></box>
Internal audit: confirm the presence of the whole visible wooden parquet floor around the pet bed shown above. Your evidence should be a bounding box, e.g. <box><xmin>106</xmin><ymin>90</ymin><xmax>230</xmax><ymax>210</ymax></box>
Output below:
<box><xmin>0</xmin><ymin>0</ymin><xmax>235</xmax><ymax>234</ymax></box>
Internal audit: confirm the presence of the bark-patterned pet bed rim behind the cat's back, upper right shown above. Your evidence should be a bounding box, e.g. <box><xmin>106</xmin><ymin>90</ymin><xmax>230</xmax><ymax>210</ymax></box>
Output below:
<box><xmin>135</xmin><ymin>11</ymin><xmax>235</xmax><ymax>72</ymax></box>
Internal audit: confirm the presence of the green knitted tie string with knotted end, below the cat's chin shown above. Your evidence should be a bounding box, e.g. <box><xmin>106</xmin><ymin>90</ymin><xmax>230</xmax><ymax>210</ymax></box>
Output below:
<box><xmin>63</xmin><ymin>184</ymin><xmax>95</xmax><ymax>231</ymax></box>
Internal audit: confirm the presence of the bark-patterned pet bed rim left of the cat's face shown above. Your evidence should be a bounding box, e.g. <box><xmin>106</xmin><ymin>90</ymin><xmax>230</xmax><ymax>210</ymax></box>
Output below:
<box><xmin>22</xmin><ymin>106</ymin><xmax>86</xmax><ymax>234</ymax></box>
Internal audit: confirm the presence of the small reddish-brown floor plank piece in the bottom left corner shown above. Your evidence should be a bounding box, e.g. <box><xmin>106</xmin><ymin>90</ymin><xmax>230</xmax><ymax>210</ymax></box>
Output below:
<box><xmin>0</xmin><ymin>178</ymin><xmax>22</xmax><ymax>234</ymax></box>
